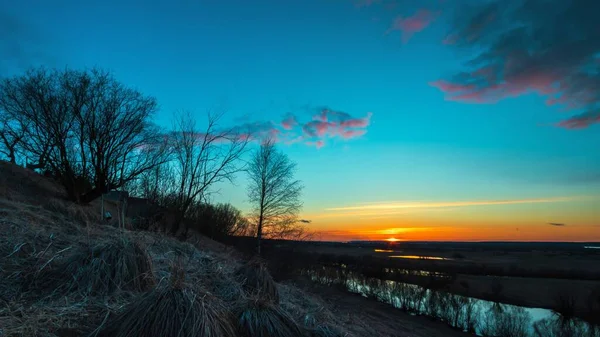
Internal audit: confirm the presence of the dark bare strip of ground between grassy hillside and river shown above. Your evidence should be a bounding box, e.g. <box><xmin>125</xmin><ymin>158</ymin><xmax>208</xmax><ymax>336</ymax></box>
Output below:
<box><xmin>294</xmin><ymin>281</ymin><xmax>471</xmax><ymax>337</ymax></box>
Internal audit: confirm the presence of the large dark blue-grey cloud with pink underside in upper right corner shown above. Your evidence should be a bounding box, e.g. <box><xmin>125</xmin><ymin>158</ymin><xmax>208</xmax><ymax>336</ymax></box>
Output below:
<box><xmin>432</xmin><ymin>0</ymin><xmax>600</xmax><ymax>129</ymax></box>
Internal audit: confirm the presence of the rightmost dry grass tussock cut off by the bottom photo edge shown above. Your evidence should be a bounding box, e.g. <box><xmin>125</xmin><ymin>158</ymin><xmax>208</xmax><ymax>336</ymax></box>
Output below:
<box><xmin>237</xmin><ymin>299</ymin><xmax>303</xmax><ymax>337</ymax></box>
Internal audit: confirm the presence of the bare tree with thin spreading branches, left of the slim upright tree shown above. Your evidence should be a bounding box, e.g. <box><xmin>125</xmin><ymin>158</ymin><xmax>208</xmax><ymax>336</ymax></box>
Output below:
<box><xmin>171</xmin><ymin>112</ymin><xmax>250</xmax><ymax>234</ymax></box>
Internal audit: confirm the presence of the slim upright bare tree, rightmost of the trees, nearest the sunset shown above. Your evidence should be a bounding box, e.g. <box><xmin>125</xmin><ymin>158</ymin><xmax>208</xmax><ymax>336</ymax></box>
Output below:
<box><xmin>247</xmin><ymin>139</ymin><xmax>303</xmax><ymax>254</ymax></box>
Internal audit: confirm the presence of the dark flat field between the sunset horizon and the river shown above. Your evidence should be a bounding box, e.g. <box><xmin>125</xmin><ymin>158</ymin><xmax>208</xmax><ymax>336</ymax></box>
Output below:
<box><xmin>237</xmin><ymin>241</ymin><xmax>600</xmax><ymax>317</ymax></box>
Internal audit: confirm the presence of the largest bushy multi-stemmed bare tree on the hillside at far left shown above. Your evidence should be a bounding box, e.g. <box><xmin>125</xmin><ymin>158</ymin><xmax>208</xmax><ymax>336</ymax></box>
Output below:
<box><xmin>0</xmin><ymin>68</ymin><xmax>167</xmax><ymax>203</ymax></box>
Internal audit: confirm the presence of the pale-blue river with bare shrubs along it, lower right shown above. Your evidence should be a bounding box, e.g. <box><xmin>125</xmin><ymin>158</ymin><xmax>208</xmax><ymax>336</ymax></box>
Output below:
<box><xmin>302</xmin><ymin>267</ymin><xmax>600</xmax><ymax>337</ymax></box>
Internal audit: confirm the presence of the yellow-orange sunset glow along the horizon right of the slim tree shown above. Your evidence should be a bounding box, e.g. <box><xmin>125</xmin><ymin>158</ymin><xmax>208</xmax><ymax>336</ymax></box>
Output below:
<box><xmin>306</xmin><ymin>195</ymin><xmax>600</xmax><ymax>243</ymax></box>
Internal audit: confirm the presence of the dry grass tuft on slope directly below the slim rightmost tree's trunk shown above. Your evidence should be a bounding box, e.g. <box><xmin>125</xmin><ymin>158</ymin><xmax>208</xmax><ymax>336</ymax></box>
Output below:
<box><xmin>235</xmin><ymin>259</ymin><xmax>279</xmax><ymax>303</ymax></box>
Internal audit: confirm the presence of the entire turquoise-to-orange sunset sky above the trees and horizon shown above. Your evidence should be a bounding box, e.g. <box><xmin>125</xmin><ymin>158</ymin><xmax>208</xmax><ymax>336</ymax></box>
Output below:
<box><xmin>0</xmin><ymin>0</ymin><xmax>600</xmax><ymax>241</ymax></box>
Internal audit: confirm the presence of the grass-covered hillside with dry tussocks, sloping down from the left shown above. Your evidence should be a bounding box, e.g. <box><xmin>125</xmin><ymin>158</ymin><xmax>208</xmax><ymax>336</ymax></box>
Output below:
<box><xmin>0</xmin><ymin>162</ymin><xmax>468</xmax><ymax>337</ymax></box>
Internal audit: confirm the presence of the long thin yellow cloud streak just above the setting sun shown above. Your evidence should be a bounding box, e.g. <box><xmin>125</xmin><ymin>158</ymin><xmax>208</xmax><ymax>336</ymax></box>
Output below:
<box><xmin>325</xmin><ymin>197</ymin><xmax>575</xmax><ymax>212</ymax></box>
